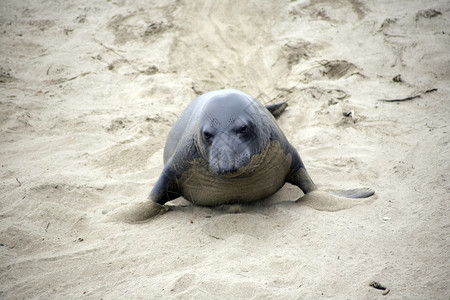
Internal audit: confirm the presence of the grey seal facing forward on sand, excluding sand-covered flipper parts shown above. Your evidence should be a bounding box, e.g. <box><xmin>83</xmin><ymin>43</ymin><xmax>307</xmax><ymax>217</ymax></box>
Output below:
<box><xmin>149</xmin><ymin>89</ymin><xmax>374</xmax><ymax>210</ymax></box>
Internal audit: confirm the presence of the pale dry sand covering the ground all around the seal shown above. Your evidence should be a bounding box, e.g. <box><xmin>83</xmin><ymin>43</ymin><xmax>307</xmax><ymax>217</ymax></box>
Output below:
<box><xmin>0</xmin><ymin>0</ymin><xmax>450</xmax><ymax>299</ymax></box>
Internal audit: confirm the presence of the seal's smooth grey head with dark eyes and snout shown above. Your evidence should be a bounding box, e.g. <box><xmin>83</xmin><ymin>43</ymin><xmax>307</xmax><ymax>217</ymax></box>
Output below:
<box><xmin>197</xmin><ymin>92</ymin><xmax>270</xmax><ymax>176</ymax></box>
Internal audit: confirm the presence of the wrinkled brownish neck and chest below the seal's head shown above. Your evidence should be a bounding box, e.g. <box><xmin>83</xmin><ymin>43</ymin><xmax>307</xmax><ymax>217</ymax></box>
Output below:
<box><xmin>178</xmin><ymin>140</ymin><xmax>292</xmax><ymax>206</ymax></box>
